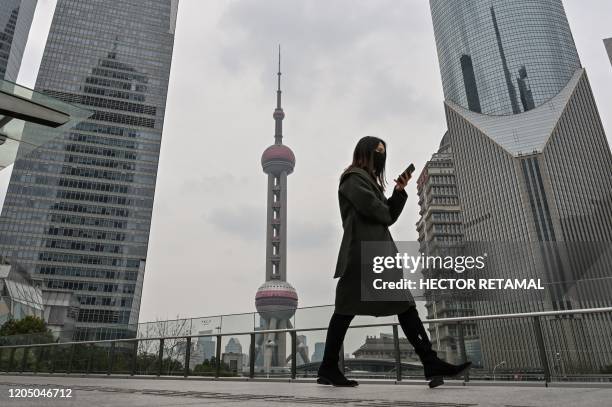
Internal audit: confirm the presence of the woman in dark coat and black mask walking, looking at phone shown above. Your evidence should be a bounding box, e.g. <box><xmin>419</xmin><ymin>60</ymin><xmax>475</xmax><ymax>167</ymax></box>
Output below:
<box><xmin>317</xmin><ymin>137</ymin><xmax>471</xmax><ymax>387</ymax></box>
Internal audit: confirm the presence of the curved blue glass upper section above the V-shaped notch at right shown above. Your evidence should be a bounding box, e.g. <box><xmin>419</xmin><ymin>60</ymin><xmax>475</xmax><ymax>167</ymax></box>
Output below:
<box><xmin>430</xmin><ymin>0</ymin><xmax>580</xmax><ymax>115</ymax></box>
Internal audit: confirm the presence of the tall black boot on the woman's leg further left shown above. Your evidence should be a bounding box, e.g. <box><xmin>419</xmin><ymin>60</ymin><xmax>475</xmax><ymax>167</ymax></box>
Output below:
<box><xmin>317</xmin><ymin>313</ymin><xmax>359</xmax><ymax>387</ymax></box>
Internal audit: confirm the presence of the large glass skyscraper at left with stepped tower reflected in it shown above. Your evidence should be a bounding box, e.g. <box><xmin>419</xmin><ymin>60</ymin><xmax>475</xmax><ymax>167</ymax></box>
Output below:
<box><xmin>0</xmin><ymin>0</ymin><xmax>178</xmax><ymax>339</ymax></box>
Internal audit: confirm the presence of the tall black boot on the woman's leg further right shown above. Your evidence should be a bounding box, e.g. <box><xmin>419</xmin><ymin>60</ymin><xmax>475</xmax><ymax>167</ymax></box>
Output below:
<box><xmin>398</xmin><ymin>307</ymin><xmax>472</xmax><ymax>388</ymax></box>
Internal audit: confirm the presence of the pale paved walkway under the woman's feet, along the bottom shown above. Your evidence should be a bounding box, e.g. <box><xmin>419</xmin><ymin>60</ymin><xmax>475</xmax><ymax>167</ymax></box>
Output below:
<box><xmin>0</xmin><ymin>375</ymin><xmax>612</xmax><ymax>407</ymax></box>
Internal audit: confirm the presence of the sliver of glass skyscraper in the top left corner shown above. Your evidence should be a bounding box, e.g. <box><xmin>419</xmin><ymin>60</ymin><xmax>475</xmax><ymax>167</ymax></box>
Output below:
<box><xmin>0</xmin><ymin>0</ymin><xmax>37</xmax><ymax>82</ymax></box>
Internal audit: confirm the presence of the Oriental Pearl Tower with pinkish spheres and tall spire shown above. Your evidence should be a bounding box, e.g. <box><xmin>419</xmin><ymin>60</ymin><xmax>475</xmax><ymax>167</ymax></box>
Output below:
<box><xmin>255</xmin><ymin>47</ymin><xmax>308</xmax><ymax>373</ymax></box>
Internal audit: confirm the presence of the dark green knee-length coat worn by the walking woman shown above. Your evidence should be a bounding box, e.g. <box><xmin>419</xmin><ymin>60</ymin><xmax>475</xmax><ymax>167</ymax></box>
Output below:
<box><xmin>334</xmin><ymin>168</ymin><xmax>414</xmax><ymax>316</ymax></box>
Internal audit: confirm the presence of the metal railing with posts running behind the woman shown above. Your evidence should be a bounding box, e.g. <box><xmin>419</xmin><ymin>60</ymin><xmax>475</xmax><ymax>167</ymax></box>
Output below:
<box><xmin>0</xmin><ymin>307</ymin><xmax>612</xmax><ymax>384</ymax></box>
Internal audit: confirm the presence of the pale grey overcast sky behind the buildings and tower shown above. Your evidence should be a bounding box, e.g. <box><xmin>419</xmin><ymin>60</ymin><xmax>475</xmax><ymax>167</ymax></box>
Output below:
<box><xmin>0</xmin><ymin>0</ymin><xmax>612</xmax><ymax>321</ymax></box>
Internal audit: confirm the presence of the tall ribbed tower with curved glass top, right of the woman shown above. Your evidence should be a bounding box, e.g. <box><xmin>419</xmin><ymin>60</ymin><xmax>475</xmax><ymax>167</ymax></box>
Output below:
<box><xmin>430</xmin><ymin>0</ymin><xmax>612</xmax><ymax>374</ymax></box>
